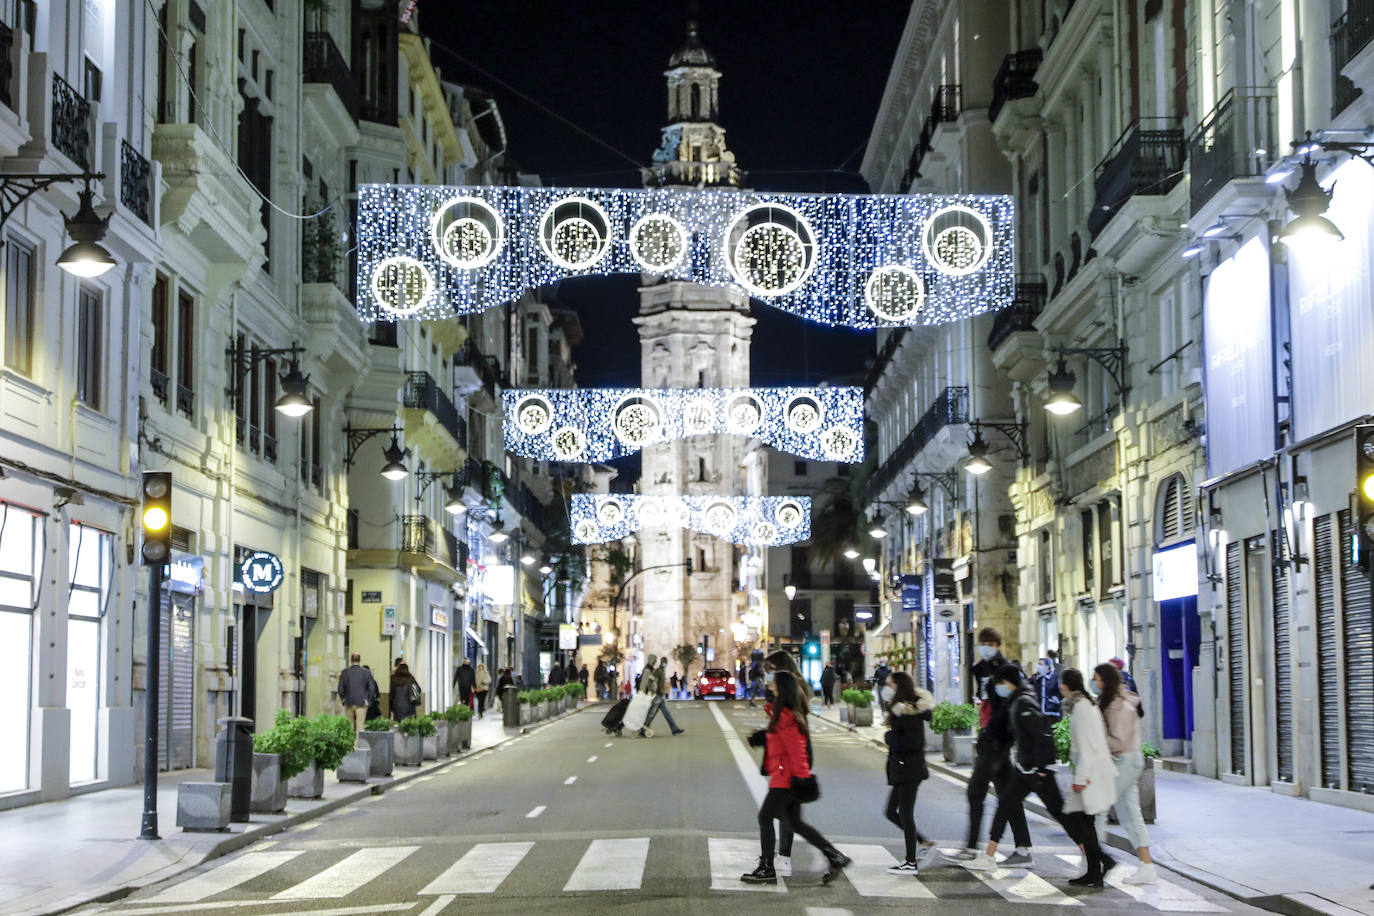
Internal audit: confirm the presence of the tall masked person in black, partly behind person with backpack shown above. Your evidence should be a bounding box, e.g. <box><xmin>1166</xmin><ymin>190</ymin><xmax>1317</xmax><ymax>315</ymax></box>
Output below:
<box><xmin>956</xmin><ymin>626</ymin><xmax>1031</xmax><ymax>868</ymax></box>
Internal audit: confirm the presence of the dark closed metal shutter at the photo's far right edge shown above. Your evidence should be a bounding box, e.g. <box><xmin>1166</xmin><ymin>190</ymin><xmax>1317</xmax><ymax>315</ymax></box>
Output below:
<box><xmin>1341</xmin><ymin>509</ymin><xmax>1374</xmax><ymax>794</ymax></box>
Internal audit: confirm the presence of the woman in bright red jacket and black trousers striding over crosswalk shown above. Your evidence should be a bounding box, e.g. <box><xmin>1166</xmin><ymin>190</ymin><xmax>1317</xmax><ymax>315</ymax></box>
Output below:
<box><xmin>739</xmin><ymin>670</ymin><xmax>849</xmax><ymax>884</ymax></box>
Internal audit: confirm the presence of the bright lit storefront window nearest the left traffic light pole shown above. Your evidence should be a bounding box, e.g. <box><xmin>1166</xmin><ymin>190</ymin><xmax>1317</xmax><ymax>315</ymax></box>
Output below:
<box><xmin>67</xmin><ymin>525</ymin><xmax>113</xmax><ymax>784</ymax></box>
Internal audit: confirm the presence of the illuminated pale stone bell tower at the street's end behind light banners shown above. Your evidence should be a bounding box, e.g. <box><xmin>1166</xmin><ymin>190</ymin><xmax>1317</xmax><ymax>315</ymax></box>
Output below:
<box><xmin>635</xmin><ymin>21</ymin><xmax>754</xmax><ymax>670</ymax></box>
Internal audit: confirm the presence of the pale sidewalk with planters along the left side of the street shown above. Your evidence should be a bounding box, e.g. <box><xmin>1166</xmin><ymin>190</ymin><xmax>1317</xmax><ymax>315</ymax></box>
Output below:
<box><xmin>0</xmin><ymin>705</ymin><xmax>585</xmax><ymax>916</ymax></box>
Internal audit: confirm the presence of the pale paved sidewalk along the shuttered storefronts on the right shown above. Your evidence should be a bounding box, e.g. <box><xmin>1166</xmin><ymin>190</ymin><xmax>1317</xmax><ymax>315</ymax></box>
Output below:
<box><xmin>815</xmin><ymin>706</ymin><xmax>1374</xmax><ymax>916</ymax></box>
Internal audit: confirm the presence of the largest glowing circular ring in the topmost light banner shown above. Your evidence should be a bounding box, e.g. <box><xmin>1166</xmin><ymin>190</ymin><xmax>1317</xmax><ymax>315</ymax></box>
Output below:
<box><xmin>724</xmin><ymin>203</ymin><xmax>819</xmax><ymax>298</ymax></box>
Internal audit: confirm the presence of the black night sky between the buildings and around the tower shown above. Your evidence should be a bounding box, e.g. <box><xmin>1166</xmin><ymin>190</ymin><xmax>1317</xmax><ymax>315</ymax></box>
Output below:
<box><xmin>418</xmin><ymin>0</ymin><xmax>910</xmax><ymax>386</ymax></box>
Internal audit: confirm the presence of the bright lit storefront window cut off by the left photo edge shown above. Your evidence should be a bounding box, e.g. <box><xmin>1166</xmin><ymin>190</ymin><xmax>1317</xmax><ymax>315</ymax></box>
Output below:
<box><xmin>0</xmin><ymin>503</ymin><xmax>43</xmax><ymax>792</ymax></box>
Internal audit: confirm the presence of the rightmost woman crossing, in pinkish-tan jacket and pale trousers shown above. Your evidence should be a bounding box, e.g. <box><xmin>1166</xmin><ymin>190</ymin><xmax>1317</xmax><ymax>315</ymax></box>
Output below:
<box><xmin>1092</xmin><ymin>663</ymin><xmax>1160</xmax><ymax>884</ymax></box>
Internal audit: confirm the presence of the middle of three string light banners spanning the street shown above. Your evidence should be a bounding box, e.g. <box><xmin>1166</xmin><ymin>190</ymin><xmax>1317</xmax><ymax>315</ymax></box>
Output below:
<box><xmin>502</xmin><ymin>386</ymin><xmax>864</xmax><ymax>464</ymax></box>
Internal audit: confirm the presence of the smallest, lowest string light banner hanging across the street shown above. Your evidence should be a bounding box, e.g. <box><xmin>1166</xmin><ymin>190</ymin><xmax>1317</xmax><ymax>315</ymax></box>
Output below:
<box><xmin>569</xmin><ymin>493</ymin><xmax>811</xmax><ymax>547</ymax></box>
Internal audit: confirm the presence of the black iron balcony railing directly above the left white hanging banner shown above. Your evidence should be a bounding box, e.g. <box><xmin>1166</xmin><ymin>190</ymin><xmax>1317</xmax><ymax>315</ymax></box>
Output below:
<box><xmin>1189</xmin><ymin>87</ymin><xmax>1278</xmax><ymax>213</ymax></box>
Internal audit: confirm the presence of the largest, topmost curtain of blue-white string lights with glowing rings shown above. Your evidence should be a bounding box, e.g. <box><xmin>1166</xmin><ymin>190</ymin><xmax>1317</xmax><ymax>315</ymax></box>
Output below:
<box><xmin>357</xmin><ymin>184</ymin><xmax>1015</xmax><ymax>328</ymax></box>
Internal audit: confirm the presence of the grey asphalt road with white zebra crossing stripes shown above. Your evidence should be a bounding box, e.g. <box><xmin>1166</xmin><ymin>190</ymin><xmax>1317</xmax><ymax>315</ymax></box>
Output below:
<box><xmin>76</xmin><ymin>703</ymin><xmax>1259</xmax><ymax>916</ymax></box>
